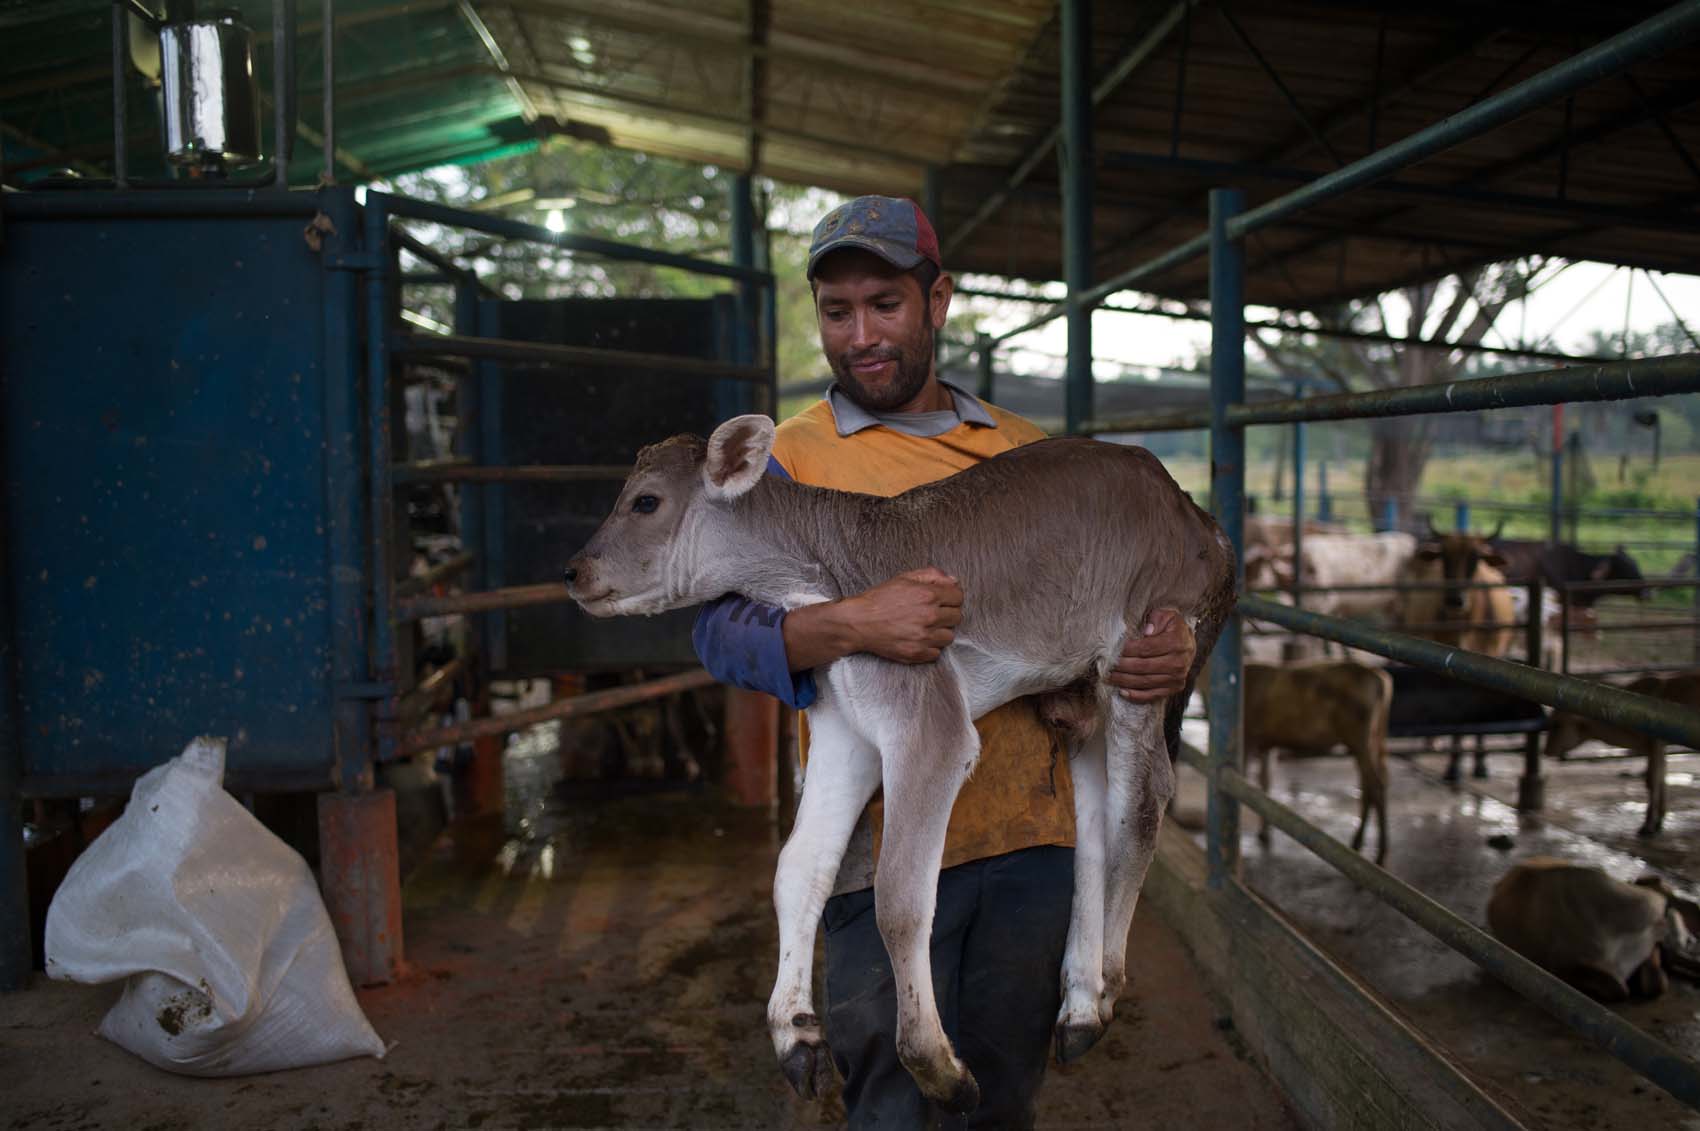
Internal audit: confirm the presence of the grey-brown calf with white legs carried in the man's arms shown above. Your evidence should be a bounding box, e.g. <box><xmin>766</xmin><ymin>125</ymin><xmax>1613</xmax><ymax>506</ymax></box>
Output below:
<box><xmin>566</xmin><ymin>415</ymin><xmax>1234</xmax><ymax>1112</ymax></box>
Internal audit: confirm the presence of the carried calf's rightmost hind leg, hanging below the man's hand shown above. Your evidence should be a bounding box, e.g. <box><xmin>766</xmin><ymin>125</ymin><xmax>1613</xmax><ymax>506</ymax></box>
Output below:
<box><xmin>1098</xmin><ymin>697</ymin><xmax>1175</xmax><ymax>1024</ymax></box>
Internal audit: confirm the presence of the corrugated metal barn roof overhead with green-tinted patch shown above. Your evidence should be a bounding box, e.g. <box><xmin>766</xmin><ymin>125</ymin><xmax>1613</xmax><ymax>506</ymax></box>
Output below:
<box><xmin>0</xmin><ymin>0</ymin><xmax>1700</xmax><ymax>306</ymax></box>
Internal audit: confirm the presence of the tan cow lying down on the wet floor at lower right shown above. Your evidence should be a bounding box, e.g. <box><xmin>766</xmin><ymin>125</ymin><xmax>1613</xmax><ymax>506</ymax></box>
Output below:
<box><xmin>1488</xmin><ymin>855</ymin><xmax>1695</xmax><ymax>1003</ymax></box>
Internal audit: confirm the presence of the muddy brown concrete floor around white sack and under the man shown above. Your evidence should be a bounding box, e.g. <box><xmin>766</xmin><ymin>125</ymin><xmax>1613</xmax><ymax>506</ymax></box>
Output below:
<box><xmin>0</xmin><ymin>743</ymin><xmax>1295</xmax><ymax>1131</ymax></box>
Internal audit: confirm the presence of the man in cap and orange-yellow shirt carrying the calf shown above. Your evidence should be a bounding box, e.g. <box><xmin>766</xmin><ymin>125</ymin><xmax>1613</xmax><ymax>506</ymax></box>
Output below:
<box><xmin>695</xmin><ymin>196</ymin><xmax>1195</xmax><ymax>1128</ymax></box>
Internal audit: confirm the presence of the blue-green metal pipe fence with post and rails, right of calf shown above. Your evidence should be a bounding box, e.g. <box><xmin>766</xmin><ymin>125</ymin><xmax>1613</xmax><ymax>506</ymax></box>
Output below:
<box><xmin>983</xmin><ymin>0</ymin><xmax>1700</xmax><ymax>1109</ymax></box>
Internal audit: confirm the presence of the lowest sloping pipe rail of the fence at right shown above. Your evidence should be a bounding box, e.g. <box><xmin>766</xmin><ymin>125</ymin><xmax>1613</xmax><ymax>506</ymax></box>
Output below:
<box><xmin>1216</xmin><ymin>769</ymin><xmax>1700</xmax><ymax>1107</ymax></box>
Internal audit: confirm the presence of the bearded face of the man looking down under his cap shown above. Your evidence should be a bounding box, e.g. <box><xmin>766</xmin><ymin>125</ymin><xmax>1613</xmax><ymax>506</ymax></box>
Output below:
<box><xmin>814</xmin><ymin>248</ymin><xmax>938</xmax><ymax>412</ymax></box>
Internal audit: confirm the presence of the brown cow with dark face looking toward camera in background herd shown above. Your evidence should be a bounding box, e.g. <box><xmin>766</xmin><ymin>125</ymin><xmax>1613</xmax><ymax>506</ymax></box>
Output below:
<box><xmin>1397</xmin><ymin>526</ymin><xmax>1516</xmax><ymax>656</ymax></box>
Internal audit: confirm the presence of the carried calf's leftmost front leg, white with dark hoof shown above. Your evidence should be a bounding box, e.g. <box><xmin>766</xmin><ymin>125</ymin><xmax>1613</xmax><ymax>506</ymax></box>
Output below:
<box><xmin>767</xmin><ymin>693</ymin><xmax>879</xmax><ymax>1099</ymax></box>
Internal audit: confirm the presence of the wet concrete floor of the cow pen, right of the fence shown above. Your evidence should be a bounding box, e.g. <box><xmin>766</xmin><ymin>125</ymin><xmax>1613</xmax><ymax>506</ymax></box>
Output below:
<box><xmin>1180</xmin><ymin>748</ymin><xmax>1700</xmax><ymax>1131</ymax></box>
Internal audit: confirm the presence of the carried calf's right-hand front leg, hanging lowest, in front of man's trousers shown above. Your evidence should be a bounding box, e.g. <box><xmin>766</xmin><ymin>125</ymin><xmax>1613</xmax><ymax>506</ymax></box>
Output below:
<box><xmin>857</xmin><ymin>653</ymin><xmax>979</xmax><ymax>1112</ymax></box>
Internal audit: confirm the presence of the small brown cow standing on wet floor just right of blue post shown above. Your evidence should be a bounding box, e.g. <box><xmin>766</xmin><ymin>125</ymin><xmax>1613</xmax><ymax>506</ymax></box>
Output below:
<box><xmin>1243</xmin><ymin>660</ymin><xmax>1392</xmax><ymax>864</ymax></box>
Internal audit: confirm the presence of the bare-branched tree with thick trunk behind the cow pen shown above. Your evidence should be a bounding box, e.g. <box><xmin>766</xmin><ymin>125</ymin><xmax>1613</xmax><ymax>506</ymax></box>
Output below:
<box><xmin>1246</xmin><ymin>257</ymin><xmax>1569</xmax><ymax>530</ymax></box>
